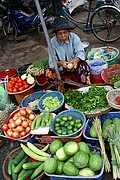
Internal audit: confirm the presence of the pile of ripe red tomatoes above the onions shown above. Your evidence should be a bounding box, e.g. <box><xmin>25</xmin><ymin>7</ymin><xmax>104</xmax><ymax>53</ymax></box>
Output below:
<box><xmin>7</xmin><ymin>76</ymin><xmax>29</xmax><ymax>93</ymax></box>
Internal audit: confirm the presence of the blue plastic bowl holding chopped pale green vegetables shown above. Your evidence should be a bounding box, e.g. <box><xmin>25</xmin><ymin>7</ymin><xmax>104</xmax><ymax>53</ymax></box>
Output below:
<box><xmin>38</xmin><ymin>91</ymin><xmax>64</xmax><ymax>113</ymax></box>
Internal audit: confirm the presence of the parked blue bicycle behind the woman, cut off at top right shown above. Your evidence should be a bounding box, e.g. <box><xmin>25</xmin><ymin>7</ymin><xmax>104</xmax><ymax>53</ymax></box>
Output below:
<box><xmin>49</xmin><ymin>0</ymin><xmax>120</xmax><ymax>43</ymax></box>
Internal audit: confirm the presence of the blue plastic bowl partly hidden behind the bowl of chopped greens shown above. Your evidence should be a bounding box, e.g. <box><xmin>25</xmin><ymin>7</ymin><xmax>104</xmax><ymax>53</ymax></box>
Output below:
<box><xmin>21</xmin><ymin>91</ymin><xmax>46</xmax><ymax>111</ymax></box>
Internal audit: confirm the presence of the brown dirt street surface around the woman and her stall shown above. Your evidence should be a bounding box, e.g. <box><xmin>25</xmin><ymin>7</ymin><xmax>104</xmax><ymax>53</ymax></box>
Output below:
<box><xmin>0</xmin><ymin>4</ymin><xmax>120</xmax><ymax>180</ymax></box>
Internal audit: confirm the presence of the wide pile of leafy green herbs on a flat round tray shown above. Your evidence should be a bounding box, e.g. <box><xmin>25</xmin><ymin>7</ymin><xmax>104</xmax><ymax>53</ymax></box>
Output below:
<box><xmin>64</xmin><ymin>85</ymin><xmax>109</xmax><ymax>113</ymax></box>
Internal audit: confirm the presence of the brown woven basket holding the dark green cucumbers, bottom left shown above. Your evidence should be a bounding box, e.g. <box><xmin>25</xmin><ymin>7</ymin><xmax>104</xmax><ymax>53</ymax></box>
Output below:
<box><xmin>2</xmin><ymin>144</ymin><xmax>44</xmax><ymax>180</ymax></box>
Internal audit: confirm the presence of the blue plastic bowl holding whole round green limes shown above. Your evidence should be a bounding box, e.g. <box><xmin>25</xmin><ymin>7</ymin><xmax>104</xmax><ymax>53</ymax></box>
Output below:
<box><xmin>50</xmin><ymin>110</ymin><xmax>86</xmax><ymax>137</ymax></box>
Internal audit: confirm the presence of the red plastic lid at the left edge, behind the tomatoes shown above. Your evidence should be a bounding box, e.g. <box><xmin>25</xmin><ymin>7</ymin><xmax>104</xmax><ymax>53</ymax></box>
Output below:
<box><xmin>0</xmin><ymin>69</ymin><xmax>17</xmax><ymax>79</ymax></box>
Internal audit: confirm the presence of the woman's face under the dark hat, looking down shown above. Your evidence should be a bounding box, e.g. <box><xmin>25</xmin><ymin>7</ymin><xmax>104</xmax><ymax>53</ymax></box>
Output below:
<box><xmin>56</xmin><ymin>29</ymin><xmax>70</xmax><ymax>42</ymax></box>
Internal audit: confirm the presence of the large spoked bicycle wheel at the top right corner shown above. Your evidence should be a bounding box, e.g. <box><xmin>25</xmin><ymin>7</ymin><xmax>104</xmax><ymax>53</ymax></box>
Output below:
<box><xmin>90</xmin><ymin>5</ymin><xmax>120</xmax><ymax>43</ymax></box>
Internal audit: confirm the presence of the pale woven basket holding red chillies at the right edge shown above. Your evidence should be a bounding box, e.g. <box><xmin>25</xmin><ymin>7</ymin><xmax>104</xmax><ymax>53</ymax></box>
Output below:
<box><xmin>106</xmin><ymin>89</ymin><xmax>120</xmax><ymax>109</ymax></box>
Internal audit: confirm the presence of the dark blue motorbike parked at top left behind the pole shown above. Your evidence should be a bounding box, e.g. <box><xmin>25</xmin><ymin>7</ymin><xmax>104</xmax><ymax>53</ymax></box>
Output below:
<box><xmin>2</xmin><ymin>2</ymin><xmax>55</xmax><ymax>39</ymax></box>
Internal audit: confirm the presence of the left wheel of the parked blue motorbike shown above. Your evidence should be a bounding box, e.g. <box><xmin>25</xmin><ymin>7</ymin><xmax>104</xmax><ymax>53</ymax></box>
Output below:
<box><xmin>3</xmin><ymin>20</ymin><xmax>18</xmax><ymax>39</ymax></box>
